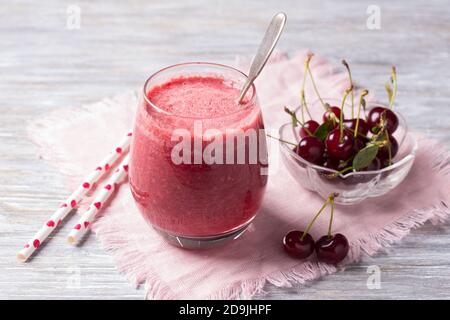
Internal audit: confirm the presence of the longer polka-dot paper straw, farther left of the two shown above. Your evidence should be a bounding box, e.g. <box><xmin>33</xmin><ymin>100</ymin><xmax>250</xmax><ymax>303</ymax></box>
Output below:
<box><xmin>17</xmin><ymin>132</ymin><xmax>132</xmax><ymax>262</ymax></box>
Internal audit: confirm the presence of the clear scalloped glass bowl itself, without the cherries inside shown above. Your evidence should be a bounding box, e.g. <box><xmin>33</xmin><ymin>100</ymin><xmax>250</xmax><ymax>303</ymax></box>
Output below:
<box><xmin>279</xmin><ymin>99</ymin><xmax>417</xmax><ymax>205</ymax></box>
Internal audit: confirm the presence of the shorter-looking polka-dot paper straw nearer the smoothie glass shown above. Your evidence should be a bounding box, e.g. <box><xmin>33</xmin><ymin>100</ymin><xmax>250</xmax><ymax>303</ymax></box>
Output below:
<box><xmin>67</xmin><ymin>155</ymin><xmax>130</xmax><ymax>245</ymax></box>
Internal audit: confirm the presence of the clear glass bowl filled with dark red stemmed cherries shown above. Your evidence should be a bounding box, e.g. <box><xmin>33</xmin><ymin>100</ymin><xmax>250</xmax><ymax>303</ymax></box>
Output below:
<box><xmin>279</xmin><ymin>59</ymin><xmax>417</xmax><ymax>205</ymax></box>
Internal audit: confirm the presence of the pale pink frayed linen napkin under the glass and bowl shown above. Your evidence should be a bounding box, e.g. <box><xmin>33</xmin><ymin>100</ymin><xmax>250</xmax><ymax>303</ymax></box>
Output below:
<box><xmin>29</xmin><ymin>52</ymin><xmax>450</xmax><ymax>299</ymax></box>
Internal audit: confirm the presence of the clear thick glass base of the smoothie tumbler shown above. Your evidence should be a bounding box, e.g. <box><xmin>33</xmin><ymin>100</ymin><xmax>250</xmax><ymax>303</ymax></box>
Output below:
<box><xmin>152</xmin><ymin>219</ymin><xmax>253</xmax><ymax>249</ymax></box>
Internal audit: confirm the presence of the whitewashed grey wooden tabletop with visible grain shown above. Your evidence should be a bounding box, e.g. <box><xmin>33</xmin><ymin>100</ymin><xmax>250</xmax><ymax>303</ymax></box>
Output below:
<box><xmin>0</xmin><ymin>0</ymin><xmax>450</xmax><ymax>299</ymax></box>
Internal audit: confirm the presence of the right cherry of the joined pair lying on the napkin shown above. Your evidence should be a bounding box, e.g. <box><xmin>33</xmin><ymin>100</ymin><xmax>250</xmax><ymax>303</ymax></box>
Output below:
<box><xmin>315</xmin><ymin>233</ymin><xmax>350</xmax><ymax>264</ymax></box>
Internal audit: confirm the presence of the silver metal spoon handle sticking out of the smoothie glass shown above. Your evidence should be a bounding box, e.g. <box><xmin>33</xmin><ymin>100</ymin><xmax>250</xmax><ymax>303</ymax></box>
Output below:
<box><xmin>238</xmin><ymin>12</ymin><xmax>287</xmax><ymax>104</ymax></box>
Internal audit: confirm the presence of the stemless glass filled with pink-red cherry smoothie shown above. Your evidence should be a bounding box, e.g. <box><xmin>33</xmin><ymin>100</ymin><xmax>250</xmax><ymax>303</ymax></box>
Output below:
<box><xmin>129</xmin><ymin>63</ymin><xmax>267</xmax><ymax>248</ymax></box>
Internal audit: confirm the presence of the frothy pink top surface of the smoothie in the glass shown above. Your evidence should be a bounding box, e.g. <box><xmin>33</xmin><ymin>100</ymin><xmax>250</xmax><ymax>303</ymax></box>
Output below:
<box><xmin>147</xmin><ymin>76</ymin><xmax>246</xmax><ymax>118</ymax></box>
